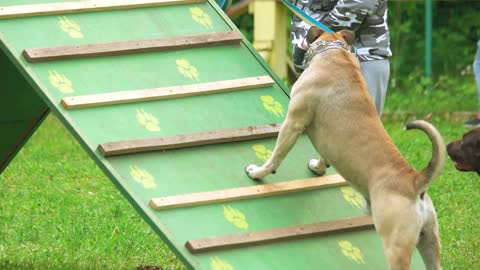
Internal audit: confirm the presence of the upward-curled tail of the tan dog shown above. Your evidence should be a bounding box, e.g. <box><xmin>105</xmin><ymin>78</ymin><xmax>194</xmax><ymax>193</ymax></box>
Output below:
<box><xmin>405</xmin><ymin>120</ymin><xmax>446</xmax><ymax>193</ymax></box>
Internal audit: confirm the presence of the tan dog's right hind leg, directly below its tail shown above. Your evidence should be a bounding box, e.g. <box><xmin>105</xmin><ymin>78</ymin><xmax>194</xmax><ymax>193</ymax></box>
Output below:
<box><xmin>417</xmin><ymin>194</ymin><xmax>441</xmax><ymax>270</ymax></box>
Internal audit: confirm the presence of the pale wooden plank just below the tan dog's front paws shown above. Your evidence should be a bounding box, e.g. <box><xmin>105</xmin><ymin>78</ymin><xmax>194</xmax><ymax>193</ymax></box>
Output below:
<box><xmin>149</xmin><ymin>174</ymin><xmax>347</xmax><ymax>210</ymax></box>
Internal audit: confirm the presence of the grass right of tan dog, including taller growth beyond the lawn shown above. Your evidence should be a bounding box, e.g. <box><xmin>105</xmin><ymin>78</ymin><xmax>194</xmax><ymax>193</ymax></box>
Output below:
<box><xmin>383</xmin><ymin>76</ymin><xmax>480</xmax><ymax>270</ymax></box>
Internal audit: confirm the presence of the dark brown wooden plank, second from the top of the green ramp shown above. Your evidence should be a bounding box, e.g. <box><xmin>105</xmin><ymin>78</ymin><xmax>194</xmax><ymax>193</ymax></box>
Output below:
<box><xmin>23</xmin><ymin>31</ymin><xmax>242</xmax><ymax>63</ymax></box>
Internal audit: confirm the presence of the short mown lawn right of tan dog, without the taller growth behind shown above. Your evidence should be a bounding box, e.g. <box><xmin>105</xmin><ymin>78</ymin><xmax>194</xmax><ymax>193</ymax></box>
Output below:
<box><xmin>385</xmin><ymin>119</ymin><xmax>480</xmax><ymax>270</ymax></box>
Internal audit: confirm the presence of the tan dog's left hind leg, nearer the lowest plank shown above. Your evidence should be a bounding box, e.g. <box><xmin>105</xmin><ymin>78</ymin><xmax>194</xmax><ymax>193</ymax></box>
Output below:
<box><xmin>371</xmin><ymin>192</ymin><xmax>422</xmax><ymax>270</ymax></box>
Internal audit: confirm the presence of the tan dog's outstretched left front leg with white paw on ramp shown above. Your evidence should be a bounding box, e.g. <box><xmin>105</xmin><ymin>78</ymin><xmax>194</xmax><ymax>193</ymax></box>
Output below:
<box><xmin>245</xmin><ymin>96</ymin><xmax>312</xmax><ymax>180</ymax></box>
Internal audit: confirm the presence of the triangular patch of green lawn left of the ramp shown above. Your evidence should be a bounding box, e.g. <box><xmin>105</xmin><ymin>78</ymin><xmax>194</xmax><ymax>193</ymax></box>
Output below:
<box><xmin>0</xmin><ymin>116</ymin><xmax>182</xmax><ymax>269</ymax></box>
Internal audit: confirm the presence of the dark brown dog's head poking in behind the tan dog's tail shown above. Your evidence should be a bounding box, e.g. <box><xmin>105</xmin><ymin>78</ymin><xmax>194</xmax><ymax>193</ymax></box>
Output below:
<box><xmin>447</xmin><ymin>128</ymin><xmax>480</xmax><ymax>175</ymax></box>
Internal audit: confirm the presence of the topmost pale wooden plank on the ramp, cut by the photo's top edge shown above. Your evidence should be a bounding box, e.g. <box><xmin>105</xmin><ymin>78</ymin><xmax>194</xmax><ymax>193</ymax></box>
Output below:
<box><xmin>0</xmin><ymin>0</ymin><xmax>206</xmax><ymax>19</ymax></box>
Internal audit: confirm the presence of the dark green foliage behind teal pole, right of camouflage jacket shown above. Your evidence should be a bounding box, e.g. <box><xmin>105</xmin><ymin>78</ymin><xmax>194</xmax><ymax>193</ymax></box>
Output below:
<box><xmin>388</xmin><ymin>0</ymin><xmax>480</xmax><ymax>89</ymax></box>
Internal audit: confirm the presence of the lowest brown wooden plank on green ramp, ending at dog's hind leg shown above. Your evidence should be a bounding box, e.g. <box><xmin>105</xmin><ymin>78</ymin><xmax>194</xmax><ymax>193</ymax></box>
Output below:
<box><xmin>185</xmin><ymin>216</ymin><xmax>374</xmax><ymax>253</ymax></box>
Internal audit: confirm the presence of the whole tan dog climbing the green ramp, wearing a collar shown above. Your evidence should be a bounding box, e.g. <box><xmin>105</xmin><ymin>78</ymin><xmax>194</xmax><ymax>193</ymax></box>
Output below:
<box><xmin>245</xmin><ymin>28</ymin><xmax>445</xmax><ymax>270</ymax></box>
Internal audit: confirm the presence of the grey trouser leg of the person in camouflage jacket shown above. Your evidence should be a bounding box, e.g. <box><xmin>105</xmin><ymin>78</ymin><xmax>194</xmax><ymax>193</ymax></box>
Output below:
<box><xmin>360</xmin><ymin>59</ymin><xmax>390</xmax><ymax>116</ymax></box>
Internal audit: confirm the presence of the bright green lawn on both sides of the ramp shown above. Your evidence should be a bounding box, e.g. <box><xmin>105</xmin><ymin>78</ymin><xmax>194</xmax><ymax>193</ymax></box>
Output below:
<box><xmin>0</xmin><ymin>77</ymin><xmax>480</xmax><ymax>269</ymax></box>
